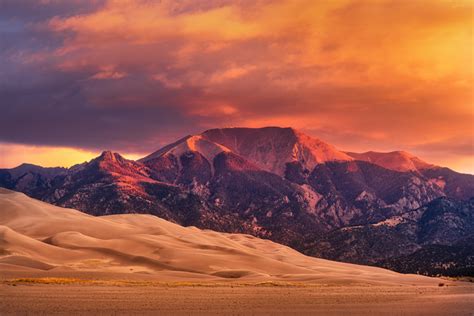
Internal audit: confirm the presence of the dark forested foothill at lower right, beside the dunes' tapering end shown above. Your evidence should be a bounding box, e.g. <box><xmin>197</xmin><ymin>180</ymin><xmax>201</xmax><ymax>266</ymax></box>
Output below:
<box><xmin>306</xmin><ymin>197</ymin><xmax>474</xmax><ymax>276</ymax></box>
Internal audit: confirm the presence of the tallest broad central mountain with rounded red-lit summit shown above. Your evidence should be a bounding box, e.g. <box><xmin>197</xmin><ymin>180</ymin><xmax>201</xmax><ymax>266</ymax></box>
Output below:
<box><xmin>140</xmin><ymin>127</ymin><xmax>456</xmax><ymax>229</ymax></box>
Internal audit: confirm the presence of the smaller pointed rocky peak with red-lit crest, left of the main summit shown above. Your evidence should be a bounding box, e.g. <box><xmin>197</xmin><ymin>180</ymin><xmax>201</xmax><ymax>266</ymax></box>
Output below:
<box><xmin>0</xmin><ymin>151</ymin><xmax>252</xmax><ymax>231</ymax></box>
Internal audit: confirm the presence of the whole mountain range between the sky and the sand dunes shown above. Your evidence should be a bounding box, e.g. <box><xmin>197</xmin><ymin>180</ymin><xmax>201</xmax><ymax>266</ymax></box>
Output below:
<box><xmin>0</xmin><ymin>127</ymin><xmax>474</xmax><ymax>275</ymax></box>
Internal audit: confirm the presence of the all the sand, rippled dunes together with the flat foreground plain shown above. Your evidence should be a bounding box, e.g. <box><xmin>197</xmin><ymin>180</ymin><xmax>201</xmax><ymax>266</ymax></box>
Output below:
<box><xmin>0</xmin><ymin>189</ymin><xmax>474</xmax><ymax>314</ymax></box>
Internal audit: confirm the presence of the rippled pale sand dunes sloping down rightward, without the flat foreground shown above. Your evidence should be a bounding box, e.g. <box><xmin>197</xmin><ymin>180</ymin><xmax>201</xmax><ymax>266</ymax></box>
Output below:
<box><xmin>0</xmin><ymin>189</ymin><xmax>439</xmax><ymax>285</ymax></box>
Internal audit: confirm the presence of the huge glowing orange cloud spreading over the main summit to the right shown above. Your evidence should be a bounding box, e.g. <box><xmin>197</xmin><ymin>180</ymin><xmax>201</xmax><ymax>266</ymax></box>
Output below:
<box><xmin>1</xmin><ymin>0</ymin><xmax>474</xmax><ymax>173</ymax></box>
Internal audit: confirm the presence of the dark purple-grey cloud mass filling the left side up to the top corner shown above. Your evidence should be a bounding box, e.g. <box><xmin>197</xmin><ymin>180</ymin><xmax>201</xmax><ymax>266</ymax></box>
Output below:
<box><xmin>0</xmin><ymin>1</ymin><xmax>209</xmax><ymax>152</ymax></box>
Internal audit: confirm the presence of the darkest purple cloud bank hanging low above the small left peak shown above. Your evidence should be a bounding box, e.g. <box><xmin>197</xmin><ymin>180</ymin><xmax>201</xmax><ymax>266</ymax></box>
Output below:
<box><xmin>0</xmin><ymin>63</ymin><xmax>206</xmax><ymax>152</ymax></box>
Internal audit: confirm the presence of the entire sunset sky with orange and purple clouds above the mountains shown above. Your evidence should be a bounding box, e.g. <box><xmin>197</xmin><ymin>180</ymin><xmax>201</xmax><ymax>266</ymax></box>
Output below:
<box><xmin>0</xmin><ymin>0</ymin><xmax>474</xmax><ymax>173</ymax></box>
